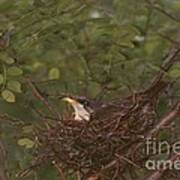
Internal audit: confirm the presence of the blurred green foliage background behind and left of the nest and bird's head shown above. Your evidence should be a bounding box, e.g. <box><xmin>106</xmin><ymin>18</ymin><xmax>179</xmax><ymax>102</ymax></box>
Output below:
<box><xmin>0</xmin><ymin>0</ymin><xmax>180</xmax><ymax>180</ymax></box>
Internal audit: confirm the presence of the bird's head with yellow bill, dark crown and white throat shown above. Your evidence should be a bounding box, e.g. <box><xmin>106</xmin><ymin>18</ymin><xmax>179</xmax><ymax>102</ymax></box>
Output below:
<box><xmin>62</xmin><ymin>96</ymin><xmax>93</xmax><ymax>121</ymax></box>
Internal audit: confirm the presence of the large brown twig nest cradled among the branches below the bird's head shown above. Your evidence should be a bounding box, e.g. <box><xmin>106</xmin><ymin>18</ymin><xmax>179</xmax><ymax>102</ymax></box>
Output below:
<box><xmin>23</xmin><ymin>90</ymin><xmax>161</xmax><ymax>179</ymax></box>
